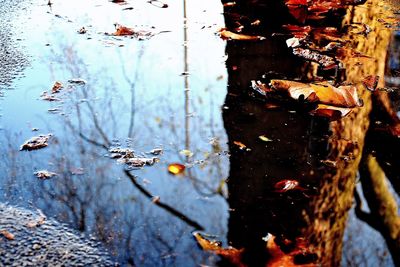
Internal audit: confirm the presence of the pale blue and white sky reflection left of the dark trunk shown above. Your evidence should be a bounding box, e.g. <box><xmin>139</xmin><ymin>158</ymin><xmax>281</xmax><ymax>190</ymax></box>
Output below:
<box><xmin>0</xmin><ymin>0</ymin><xmax>229</xmax><ymax>264</ymax></box>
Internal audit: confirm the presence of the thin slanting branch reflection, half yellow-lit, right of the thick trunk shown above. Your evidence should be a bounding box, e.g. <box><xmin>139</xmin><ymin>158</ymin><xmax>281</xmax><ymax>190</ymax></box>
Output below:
<box><xmin>360</xmin><ymin>155</ymin><xmax>400</xmax><ymax>266</ymax></box>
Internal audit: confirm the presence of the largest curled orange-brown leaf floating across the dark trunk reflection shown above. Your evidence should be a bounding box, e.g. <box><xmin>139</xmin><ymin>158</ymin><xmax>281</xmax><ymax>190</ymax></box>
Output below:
<box><xmin>271</xmin><ymin>80</ymin><xmax>363</xmax><ymax>108</ymax></box>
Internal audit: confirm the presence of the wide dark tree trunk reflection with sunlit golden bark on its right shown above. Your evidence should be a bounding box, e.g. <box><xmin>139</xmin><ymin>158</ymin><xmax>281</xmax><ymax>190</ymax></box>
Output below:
<box><xmin>224</xmin><ymin>0</ymin><xmax>396</xmax><ymax>266</ymax></box>
